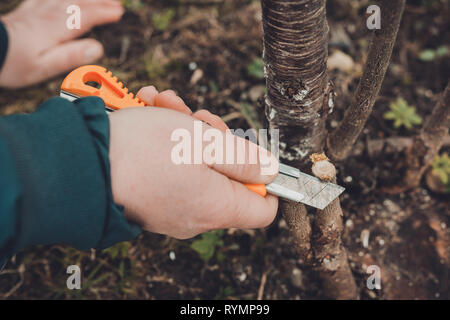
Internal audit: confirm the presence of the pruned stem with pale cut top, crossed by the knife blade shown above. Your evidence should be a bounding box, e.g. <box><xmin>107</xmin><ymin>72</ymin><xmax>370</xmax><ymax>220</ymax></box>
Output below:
<box><xmin>312</xmin><ymin>160</ymin><xmax>359</xmax><ymax>300</ymax></box>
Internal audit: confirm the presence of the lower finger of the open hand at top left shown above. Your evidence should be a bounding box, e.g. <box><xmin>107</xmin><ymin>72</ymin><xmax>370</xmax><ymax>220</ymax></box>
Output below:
<box><xmin>30</xmin><ymin>39</ymin><xmax>104</xmax><ymax>82</ymax></box>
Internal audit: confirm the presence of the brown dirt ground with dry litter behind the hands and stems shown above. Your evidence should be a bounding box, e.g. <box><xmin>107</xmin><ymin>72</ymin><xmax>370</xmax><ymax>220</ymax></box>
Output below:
<box><xmin>0</xmin><ymin>0</ymin><xmax>450</xmax><ymax>299</ymax></box>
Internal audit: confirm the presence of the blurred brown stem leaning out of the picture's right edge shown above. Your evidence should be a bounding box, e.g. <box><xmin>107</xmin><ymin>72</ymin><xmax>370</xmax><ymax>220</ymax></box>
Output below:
<box><xmin>401</xmin><ymin>81</ymin><xmax>450</xmax><ymax>190</ymax></box>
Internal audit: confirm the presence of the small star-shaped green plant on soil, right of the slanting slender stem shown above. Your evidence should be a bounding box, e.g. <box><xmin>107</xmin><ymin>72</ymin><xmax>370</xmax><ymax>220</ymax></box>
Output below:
<box><xmin>384</xmin><ymin>97</ymin><xmax>422</xmax><ymax>129</ymax></box>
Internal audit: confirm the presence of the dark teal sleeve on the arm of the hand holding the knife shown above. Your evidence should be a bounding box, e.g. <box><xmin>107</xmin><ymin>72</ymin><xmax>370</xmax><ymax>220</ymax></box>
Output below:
<box><xmin>0</xmin><ymin>97</ymin><xmax>141</xmax><ymax>267</ymax></box>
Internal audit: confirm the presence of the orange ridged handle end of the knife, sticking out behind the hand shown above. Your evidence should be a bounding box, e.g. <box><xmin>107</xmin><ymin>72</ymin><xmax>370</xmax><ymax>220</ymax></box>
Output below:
<box><xmin>61</xmin><ymin>65</ymin><xmax>146</xmax><ymax>110</ymax></box>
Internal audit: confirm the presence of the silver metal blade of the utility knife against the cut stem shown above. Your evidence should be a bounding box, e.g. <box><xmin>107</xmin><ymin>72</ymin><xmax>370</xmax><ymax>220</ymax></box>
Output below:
<box><xmin>267</xmin><ymin>164</ymin><xmax>345</xmax><ymax>210</ymax></box>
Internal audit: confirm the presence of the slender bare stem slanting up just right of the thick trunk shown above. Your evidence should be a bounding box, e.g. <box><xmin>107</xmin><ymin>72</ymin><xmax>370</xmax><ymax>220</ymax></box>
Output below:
<box><xmin>327</xmin><ymin>0</ymin><xmax>405</xmax><ymax>161</ymax></box>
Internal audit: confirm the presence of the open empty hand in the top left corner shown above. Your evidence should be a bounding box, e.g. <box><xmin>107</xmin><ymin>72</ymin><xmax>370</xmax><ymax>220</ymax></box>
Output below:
<box><xmin>0</xmin><ymin>0</ymin><xmax>124</xmax><ymax>88</ymax></box>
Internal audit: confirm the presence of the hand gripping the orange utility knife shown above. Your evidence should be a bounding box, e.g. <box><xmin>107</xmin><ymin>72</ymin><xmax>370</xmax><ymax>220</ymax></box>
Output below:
<box><xmin>110</xmin><ymin>87</ymin><xmax>278</xmax><ymax>239</ymax></box>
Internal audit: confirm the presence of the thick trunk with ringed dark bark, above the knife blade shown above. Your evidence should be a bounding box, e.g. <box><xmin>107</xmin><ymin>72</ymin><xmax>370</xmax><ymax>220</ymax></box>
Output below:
<box><xmin>261</xmin><ymin>0</ymin><xmax>329</xmax><ymax>168</ymax></box>
